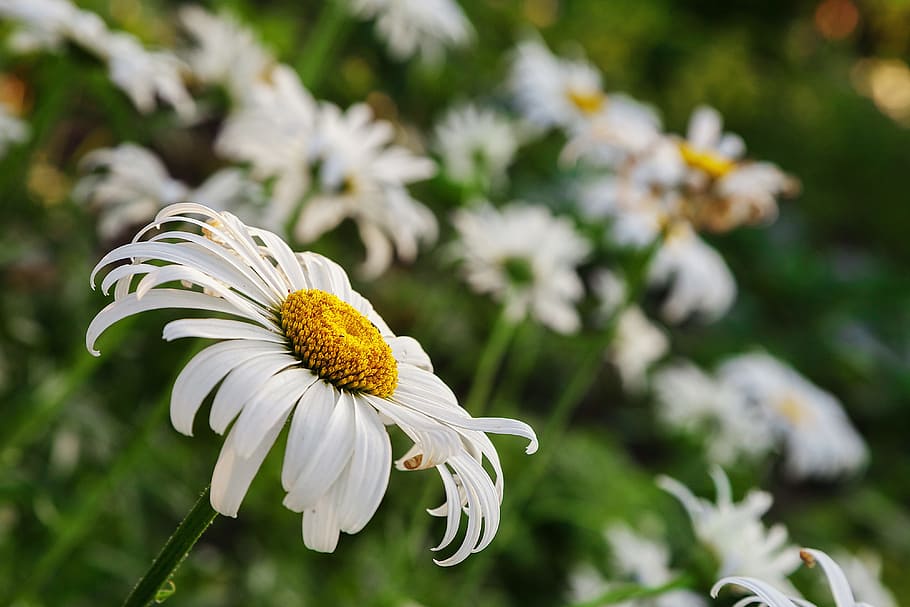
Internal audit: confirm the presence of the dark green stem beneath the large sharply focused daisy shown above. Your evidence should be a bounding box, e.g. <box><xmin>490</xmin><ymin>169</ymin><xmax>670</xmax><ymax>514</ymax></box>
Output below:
<box><xmin>123</xmin><ymin>486</ymin><xmax>218</xmax><ymax>607</ymax></box>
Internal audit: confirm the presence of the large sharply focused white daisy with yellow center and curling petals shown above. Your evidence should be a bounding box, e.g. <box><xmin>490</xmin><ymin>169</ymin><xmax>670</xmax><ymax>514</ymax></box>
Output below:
<box><xmin>86</xmin><ymin>203</ymin><xmax>537</xmax><ymax>565</ymax></box>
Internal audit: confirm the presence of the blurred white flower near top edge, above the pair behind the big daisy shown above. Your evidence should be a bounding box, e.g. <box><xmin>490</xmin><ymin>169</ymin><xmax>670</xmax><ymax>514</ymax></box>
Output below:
<box><xmin>180</xmin><ymin>6</ymin><xmax>275</xmax><ymax>102</ymax></box>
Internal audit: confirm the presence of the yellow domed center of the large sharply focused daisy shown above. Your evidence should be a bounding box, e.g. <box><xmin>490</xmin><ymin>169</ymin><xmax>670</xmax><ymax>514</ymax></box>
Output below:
<box><xmin>281</xmin><ymin>289</ymin><xmax>398</xmax><ymax>398</ymax></box>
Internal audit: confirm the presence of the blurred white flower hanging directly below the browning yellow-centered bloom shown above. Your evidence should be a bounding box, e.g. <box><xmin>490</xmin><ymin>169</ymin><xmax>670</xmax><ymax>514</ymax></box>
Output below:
<box><xmin>648</xmin><ymin>222</ymin><xmax>736</xmax><ymax>324</ymax></box>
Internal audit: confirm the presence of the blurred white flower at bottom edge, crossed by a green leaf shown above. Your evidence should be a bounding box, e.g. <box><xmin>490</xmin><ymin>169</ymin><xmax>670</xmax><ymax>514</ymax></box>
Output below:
<box><xmin>604</xmin><ymin>523</ymin><xmax>705</xmax><ymax>607</ymax></box>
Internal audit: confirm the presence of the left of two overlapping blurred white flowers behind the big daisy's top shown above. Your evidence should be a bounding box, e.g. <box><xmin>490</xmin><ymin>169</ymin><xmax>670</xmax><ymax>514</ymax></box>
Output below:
<box><xmin>215</xmin><ymin>65</ymin><xmax>316</xmax><ymax>230</ymax></box>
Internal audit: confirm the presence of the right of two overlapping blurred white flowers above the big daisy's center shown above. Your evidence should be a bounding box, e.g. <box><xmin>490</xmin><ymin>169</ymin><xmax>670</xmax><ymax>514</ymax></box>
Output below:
<box><xmin>302</xmin><ymin>103</ymin><xmax>437</xmax><ymax>276</ymax></box>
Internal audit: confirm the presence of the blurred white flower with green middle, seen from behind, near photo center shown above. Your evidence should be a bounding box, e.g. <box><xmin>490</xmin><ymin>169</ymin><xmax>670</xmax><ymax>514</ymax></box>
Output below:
<box><xmin>452</xmin><ymin>202</ymin><xmax>590</xmax><ymax>333</ymax></box>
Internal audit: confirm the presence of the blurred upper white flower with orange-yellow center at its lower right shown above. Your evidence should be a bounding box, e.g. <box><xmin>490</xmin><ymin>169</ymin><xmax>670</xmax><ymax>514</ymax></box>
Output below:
<box><xmin>509</xmin><ymin>40</ymin><xmax>606</xmax><ymax>131</ymax></box>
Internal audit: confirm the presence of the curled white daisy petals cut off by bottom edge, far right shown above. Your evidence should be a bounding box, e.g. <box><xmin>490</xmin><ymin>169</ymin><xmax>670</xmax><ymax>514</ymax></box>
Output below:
<box><xmin>711</xmin><ymin>548</ymin><xmax>881</xmax><ymax>607</ymax></box>
